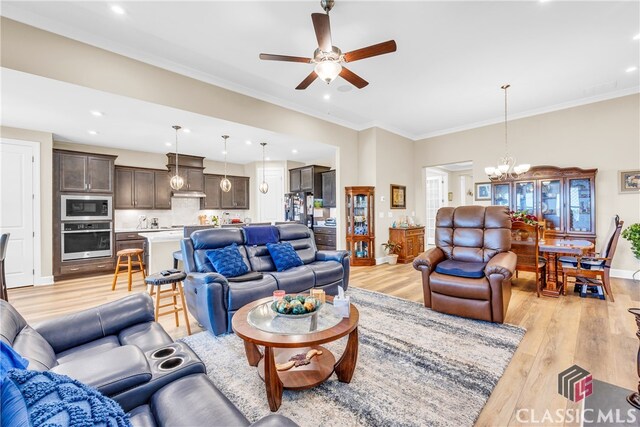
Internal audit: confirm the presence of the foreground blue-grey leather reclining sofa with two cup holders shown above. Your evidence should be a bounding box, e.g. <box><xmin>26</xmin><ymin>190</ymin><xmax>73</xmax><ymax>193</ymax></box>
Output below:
<box><xmin>0</xmin><ymin>293</ymin><xmax>297</xmax><ymax>427</ymax></box>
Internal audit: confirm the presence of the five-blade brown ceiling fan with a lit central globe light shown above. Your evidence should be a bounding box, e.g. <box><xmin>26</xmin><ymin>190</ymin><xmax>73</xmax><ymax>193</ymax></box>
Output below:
<box><xmin>260</xmin><ymin>0</ymin><xmax>396</xmax><ymax>90</ymax></box>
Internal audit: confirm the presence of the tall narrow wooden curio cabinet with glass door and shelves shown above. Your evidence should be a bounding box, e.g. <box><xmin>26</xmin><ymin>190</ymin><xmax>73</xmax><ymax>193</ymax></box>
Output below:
<box><xmin>345</xmin><ymin>187</ymin><xmax>376</xmax><ymax>266</ymax></box>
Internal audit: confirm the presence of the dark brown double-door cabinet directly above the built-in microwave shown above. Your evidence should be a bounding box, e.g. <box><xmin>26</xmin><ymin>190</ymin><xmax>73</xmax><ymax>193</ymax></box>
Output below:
<box><xmin>54</xmin><ymin>150</ymin><xmax>116</xmax><ymax>193</ymax></box>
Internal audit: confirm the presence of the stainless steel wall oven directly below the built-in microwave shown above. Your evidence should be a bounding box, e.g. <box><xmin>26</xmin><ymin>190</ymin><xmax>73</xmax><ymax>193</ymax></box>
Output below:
<box><xmin>60</xmin><ymin>222</ymin><xmax>113</xmax><ymax>261</ymax></box>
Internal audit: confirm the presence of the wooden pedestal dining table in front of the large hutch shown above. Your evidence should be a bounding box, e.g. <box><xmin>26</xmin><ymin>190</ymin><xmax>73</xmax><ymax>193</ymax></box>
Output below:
<box><xmin>538</xmin><ymin>239</ymin><xmax>595</xmax><ymax>297</ymax></box>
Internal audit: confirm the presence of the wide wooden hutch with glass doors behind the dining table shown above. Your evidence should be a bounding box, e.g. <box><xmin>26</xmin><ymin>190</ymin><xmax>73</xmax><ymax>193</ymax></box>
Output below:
<box><xmin>491</xmin><ymin>166</ymin><xmax>598</xmax><ymax>242</ymax></box>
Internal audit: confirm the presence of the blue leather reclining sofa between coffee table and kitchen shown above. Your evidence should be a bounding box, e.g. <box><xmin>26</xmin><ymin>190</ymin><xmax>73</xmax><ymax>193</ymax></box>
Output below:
<box><xmin>182</xmin><ymin>224</ymin><xmax>349</xmax><ymax>335</ymax></box>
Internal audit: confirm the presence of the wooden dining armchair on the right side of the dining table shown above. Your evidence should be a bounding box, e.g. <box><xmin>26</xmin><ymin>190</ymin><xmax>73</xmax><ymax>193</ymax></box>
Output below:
<box><xmin>558</xmin><ymin>215</ymin><xmax>624</xmax><ymax>302</ymax></box>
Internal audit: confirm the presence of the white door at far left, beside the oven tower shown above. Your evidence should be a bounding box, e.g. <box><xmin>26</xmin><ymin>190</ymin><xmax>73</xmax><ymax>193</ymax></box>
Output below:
<box><xmin>0</xmin><ymin>141</ymin><xmax>34</xmax><ymax>288</ymax></box>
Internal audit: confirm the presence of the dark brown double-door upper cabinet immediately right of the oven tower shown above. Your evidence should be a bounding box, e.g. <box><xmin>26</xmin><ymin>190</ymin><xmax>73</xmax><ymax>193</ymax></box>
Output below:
<box><xmin>115</xmin><ymin>167</ymin><xmax>155</xmax><ymax>209</ymax></box>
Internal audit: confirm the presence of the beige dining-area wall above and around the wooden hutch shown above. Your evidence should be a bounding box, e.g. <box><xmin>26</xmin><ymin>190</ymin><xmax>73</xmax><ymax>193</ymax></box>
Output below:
<box><xmin>414</xmin><ymin>95</ymin><xmax>640</xmax><ymax>271</ymax></box>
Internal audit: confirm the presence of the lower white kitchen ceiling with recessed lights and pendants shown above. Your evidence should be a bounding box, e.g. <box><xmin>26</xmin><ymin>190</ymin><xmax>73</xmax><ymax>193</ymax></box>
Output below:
<box><xmin>0</xmin><ymin>68</ymin><xmax>335</xmax><ymax>164</ymax></box>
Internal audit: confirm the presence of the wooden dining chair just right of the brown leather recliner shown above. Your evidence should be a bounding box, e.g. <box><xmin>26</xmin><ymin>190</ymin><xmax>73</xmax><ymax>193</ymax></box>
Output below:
<box><xmin>511</xmin><ymin>222</ymin><xmax>547</xmax><ymax>297</ymax></box>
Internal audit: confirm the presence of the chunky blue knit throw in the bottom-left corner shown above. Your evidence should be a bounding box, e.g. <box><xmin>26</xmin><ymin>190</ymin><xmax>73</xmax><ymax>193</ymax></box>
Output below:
<box><xmin>2</xmin><ymin>369</ymin><xmax>131</xmax><ymax>427</ymax></box>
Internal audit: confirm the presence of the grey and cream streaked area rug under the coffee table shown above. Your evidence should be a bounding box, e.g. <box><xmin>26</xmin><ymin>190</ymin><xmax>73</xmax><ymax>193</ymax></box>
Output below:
<box><xmin>182</xmin><ymin>287</ymin><xmax>525</xmax><ymax>426</ymax></box>
